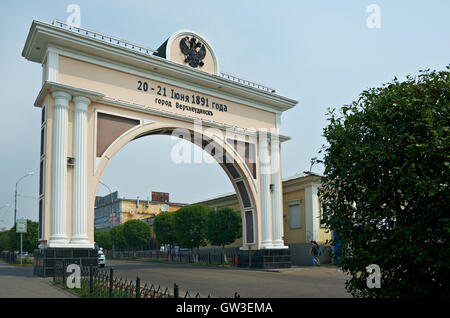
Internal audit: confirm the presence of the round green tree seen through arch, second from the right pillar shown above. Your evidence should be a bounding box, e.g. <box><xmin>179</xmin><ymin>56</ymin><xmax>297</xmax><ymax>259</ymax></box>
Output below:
<box><xmin>175</xmin><ymin>204</ymin><xmax>211</xmax><ymax>261</ymax></box>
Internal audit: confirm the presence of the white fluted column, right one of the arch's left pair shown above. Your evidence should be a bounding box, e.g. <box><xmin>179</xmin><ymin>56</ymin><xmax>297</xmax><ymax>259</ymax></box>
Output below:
<box><xmin>71</xmin><ymin>96</ymin><xmax>91</xmax><ymax>247</ymax></box>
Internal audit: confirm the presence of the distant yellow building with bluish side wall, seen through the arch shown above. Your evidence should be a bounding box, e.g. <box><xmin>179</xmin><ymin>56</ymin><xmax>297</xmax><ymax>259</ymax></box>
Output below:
<box><xmin>94</xmin><ymin>191</ymin><xmax>186</xmax><ymax>231</ymax></box>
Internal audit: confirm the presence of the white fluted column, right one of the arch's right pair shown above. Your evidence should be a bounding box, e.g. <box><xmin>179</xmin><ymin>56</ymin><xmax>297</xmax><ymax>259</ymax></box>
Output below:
<box><xmin>270</xmin><ymin>135</ymin><xmax>287</xmax><ymax>248</ymax></box>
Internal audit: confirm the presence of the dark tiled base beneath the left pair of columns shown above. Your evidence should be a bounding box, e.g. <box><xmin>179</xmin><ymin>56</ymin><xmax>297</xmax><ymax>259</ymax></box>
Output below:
<box><xmin>34</xmin><ymin>247</ymin><xmax>98</xmax><ymax>277</ymax></box>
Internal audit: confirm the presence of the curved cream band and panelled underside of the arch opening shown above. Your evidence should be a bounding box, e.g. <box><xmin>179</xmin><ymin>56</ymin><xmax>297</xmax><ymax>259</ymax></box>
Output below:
<box><xmin>88</xmin><ymin>122</ymin><xmax>259</xmax><ymax>248</ymax></box>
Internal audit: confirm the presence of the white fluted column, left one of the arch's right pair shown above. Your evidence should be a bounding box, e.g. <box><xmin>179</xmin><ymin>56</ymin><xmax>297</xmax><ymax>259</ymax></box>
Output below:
<box><xmin>258</xmin><ymin>131</ymin><xmax>272</xmax><ymax>248</ymax></box>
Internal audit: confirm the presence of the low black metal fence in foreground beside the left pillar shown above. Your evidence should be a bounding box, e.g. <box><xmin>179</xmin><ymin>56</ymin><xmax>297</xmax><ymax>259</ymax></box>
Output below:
<box><xmin>53</xmin><ymin>262</ymin><xmax>211</xmax><ymax>298</ymax></box>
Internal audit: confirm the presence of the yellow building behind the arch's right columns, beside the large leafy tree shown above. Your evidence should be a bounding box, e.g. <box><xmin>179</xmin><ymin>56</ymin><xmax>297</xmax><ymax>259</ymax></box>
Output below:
<box><xmin>197</xmin><ymin>173</ymin><xmax>331</xmax><ymax>247</ymax></box>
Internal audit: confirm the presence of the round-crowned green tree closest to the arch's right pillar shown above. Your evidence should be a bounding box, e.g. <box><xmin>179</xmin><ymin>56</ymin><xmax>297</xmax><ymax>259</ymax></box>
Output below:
<box><xmin>206</xmin><ymin>208</ymin><xmax>242</xmax><ymax>262</ymax></box>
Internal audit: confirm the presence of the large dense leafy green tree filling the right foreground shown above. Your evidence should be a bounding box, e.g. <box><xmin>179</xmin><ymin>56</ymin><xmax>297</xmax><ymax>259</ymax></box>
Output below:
<box><xmin>320</xmin><ymin>67</ymin><xmax>450</xmax><ymax>298</ymax></box>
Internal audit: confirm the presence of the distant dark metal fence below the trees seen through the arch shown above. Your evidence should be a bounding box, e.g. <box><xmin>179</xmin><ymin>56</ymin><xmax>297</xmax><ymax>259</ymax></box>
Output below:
<box><xmin>105</xmin><ymin>250</ymin><xmax>237</xmax><ymax>265</ymax></box>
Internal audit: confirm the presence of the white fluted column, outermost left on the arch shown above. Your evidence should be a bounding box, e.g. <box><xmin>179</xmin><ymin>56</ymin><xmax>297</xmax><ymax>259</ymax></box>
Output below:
<box><xmin>48</xmin><ymin>91</ymin><xmax>71</xmax><ymax>247</ymax></box>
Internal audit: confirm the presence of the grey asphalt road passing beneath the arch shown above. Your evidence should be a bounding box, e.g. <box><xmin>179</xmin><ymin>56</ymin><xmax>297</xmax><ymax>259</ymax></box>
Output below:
<box><xmin>106</xmin><ymin>260</ymin><xmax>351</xmax><ymax>298</ymax></box>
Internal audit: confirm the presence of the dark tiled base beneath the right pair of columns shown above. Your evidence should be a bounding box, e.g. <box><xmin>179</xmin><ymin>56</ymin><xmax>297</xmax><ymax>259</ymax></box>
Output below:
<box><xmin>238</xmin><ymin>246</ymin><xmax>292</xmax><ymax>269</ymax></box>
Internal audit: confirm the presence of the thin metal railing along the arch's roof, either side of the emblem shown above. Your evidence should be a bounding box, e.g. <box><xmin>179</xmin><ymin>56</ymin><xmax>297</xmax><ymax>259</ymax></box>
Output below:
<box><xmin>49</xmin><ymin>20</ymin><xmax>275</xmax><ymax>93</ymax></box>
